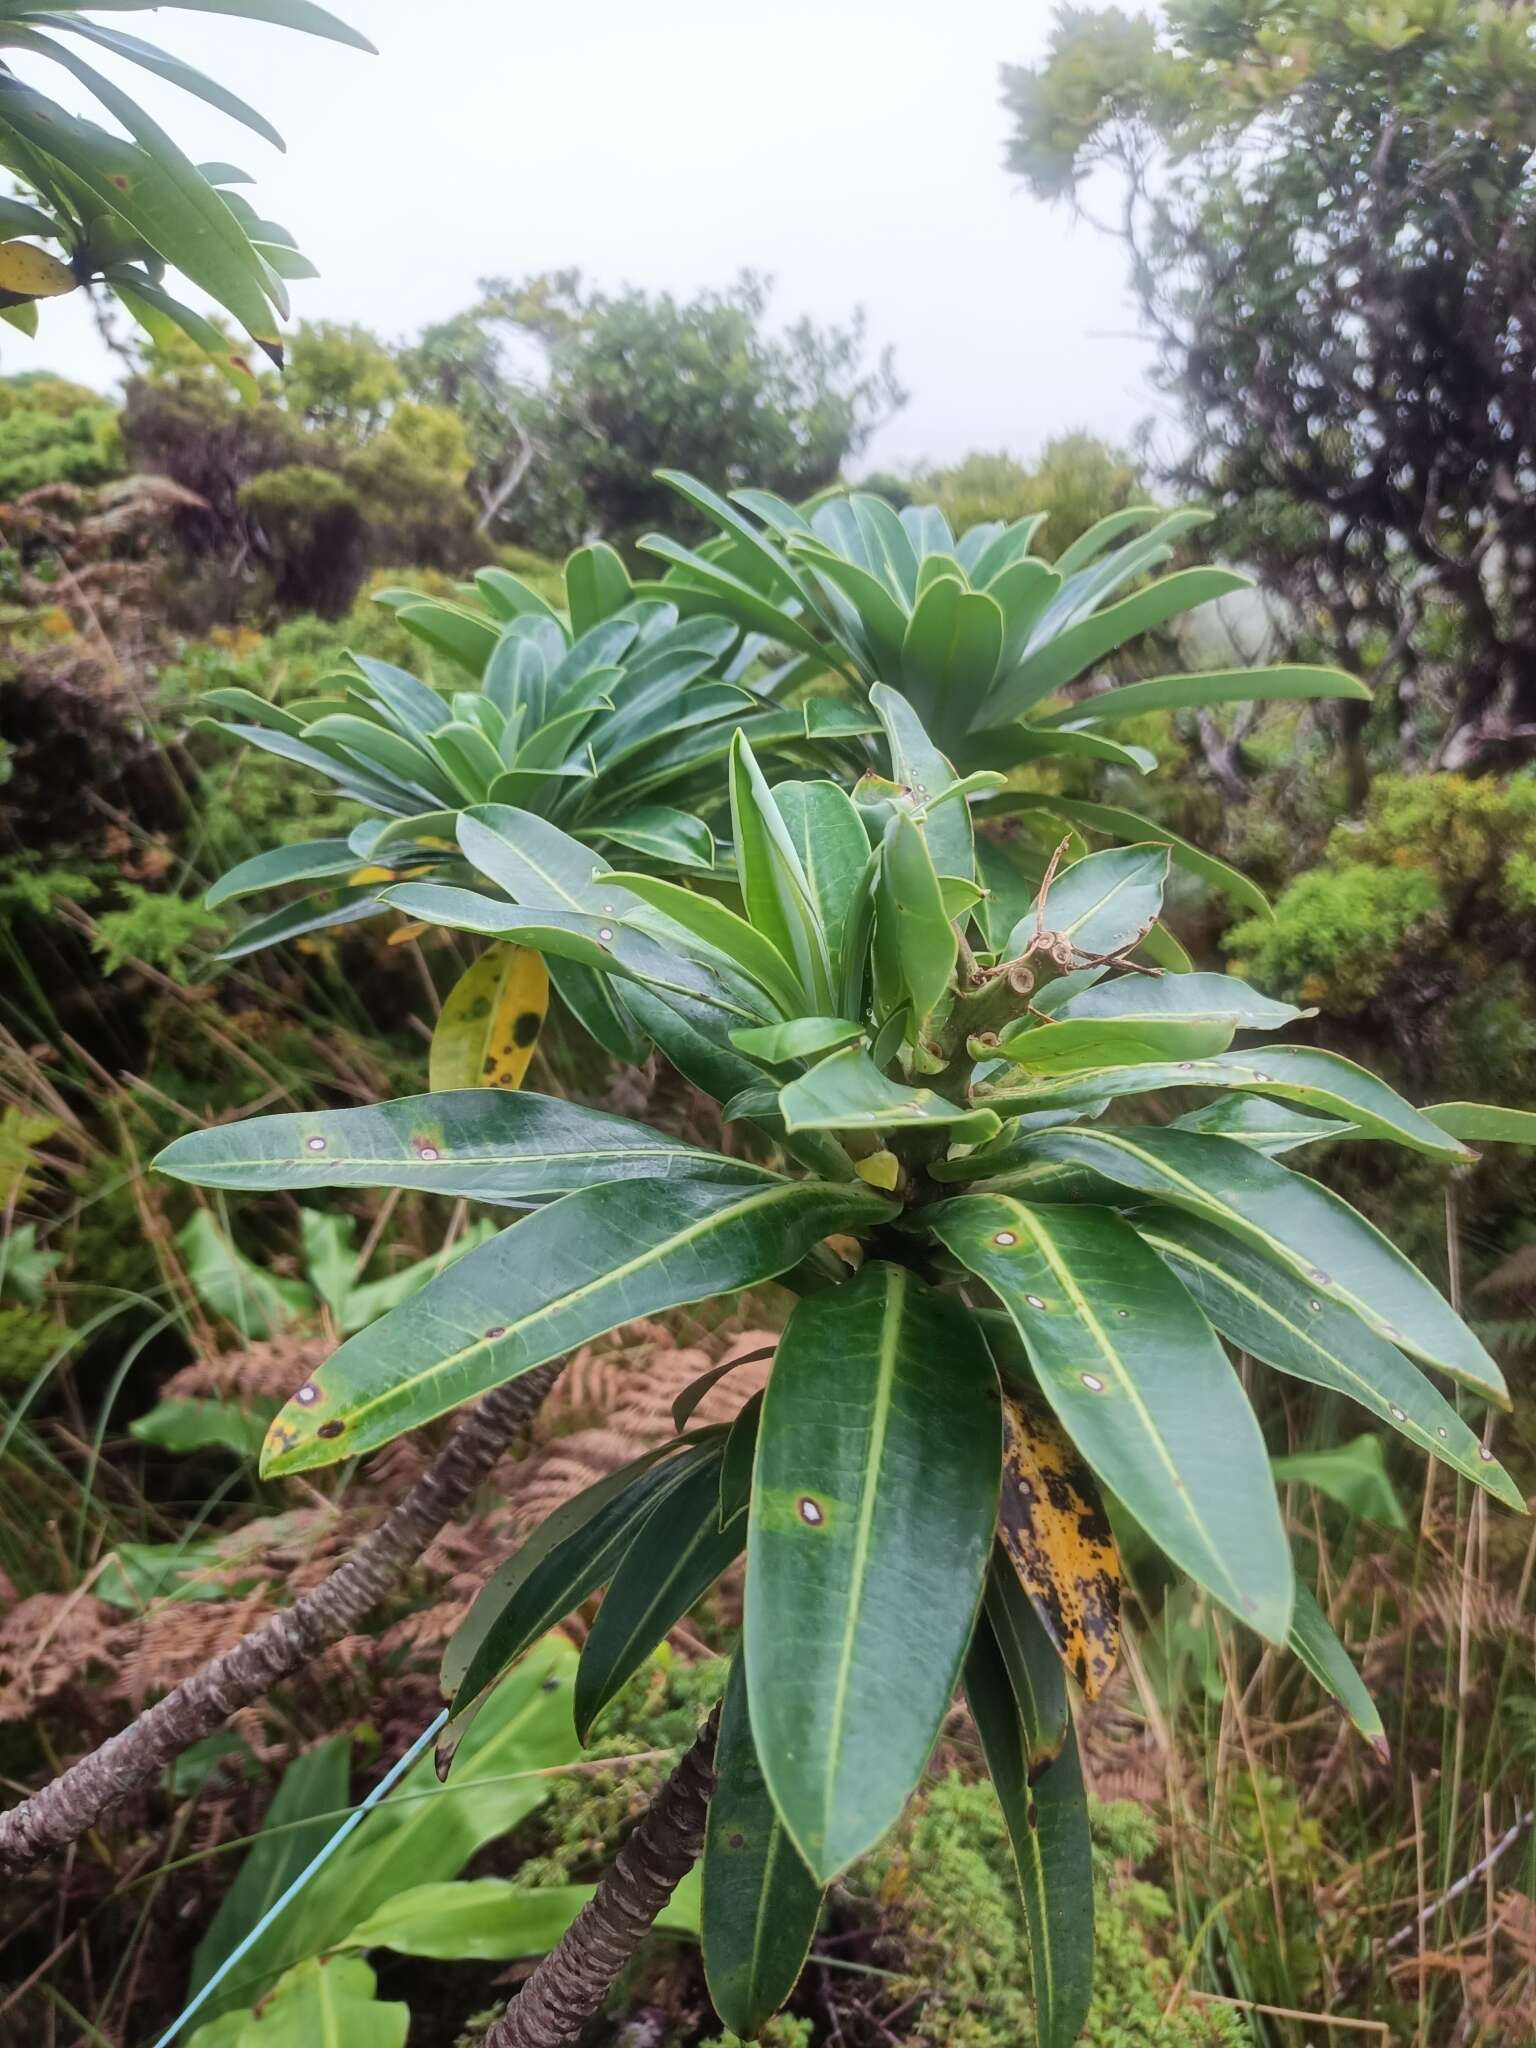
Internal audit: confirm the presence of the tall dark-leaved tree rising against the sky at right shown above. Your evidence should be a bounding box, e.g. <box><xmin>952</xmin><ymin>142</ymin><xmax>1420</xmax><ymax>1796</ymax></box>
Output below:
<box><xmin>1004</xmin><ymin>0</ymin><xmax>1536</xmax><ymax>793</ymax></box>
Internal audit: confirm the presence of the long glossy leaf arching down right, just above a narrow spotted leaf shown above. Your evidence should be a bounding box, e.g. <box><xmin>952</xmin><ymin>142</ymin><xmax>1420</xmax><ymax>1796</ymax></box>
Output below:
<box><xmin>991</xmin><ymin>1128</ymin><xmax>1509</xmax><ymax>1407</ymax></box>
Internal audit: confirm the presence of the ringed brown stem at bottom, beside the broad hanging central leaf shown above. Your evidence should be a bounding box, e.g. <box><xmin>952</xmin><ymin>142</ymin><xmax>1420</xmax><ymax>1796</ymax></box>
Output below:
<box><xmin>483</xmin><ymin>1706</ymin><xmax>721</xmax><ymax>2048</ymax></box>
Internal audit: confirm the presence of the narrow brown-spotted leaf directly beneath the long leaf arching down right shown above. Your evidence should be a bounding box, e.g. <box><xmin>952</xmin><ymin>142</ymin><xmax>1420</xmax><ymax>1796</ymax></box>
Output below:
<box><xmin>1133</xmin><ymin>1206</ymin><xmax>1526</xmax><ymax>1509</ymax></box>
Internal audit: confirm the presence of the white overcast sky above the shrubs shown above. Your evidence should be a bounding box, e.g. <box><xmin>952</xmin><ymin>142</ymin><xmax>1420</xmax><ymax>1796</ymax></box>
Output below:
<box><xmin>0</xmin><ymin>0</ymin><xmax>1155</xmax><ymax>465</ymax></box>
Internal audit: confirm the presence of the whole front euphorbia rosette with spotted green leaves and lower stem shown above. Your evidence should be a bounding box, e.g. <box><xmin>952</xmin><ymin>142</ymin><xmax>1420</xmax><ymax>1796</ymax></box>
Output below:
<box><xmin>160</xmin><ymin>684</ymin><xmax>1520</xmax><ymax>2048</ymax></box>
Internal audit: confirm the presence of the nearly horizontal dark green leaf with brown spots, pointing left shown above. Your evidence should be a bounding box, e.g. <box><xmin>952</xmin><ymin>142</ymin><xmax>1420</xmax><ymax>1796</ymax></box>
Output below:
<box><xmin>154</xmin><ymin>1087</ymin><xmax>776</xmax><ymax>1208</ymax></box>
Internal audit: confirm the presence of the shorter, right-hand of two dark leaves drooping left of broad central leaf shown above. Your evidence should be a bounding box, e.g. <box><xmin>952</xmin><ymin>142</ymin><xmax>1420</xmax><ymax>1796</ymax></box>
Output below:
<box><xmin>575</xmin><ymin>1456</ymin><xmax>748</xmax><ymax>1743</ymax></box>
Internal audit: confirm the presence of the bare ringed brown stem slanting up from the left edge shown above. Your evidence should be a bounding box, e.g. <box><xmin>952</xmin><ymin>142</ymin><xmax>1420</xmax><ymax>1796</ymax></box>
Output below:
<box><xmin>0</xmin><ymin>1360</ymin><xmax>563</xmax><ymax>1874</ymax></box>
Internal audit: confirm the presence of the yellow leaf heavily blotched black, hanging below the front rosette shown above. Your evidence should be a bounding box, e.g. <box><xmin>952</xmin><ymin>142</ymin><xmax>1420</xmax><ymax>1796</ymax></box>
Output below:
<box><xmin>997</xmin><ymin>1393</ymin><xmax>1120</xmax><ymax>1700</ymax></box>
